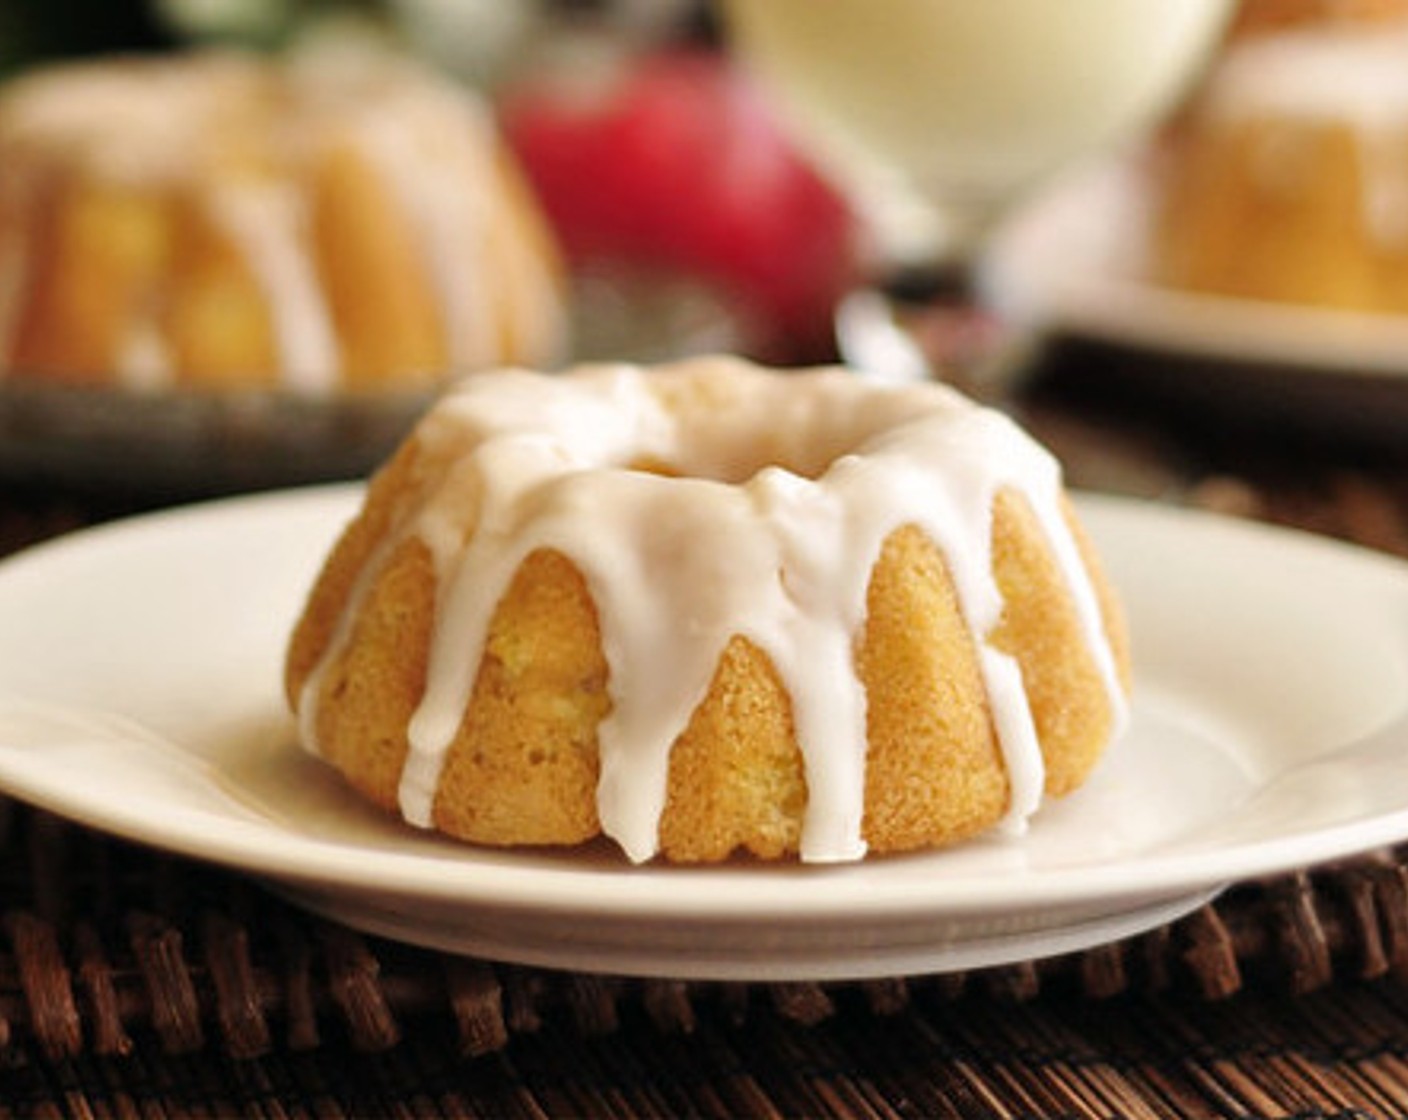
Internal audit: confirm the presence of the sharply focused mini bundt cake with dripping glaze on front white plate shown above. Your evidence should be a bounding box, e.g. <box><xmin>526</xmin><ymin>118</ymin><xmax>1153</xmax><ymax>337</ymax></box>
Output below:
<box><xmin>286</xmin><ymin>358</ymin><xmax>1128</xmax><ymax>862</ymax></box>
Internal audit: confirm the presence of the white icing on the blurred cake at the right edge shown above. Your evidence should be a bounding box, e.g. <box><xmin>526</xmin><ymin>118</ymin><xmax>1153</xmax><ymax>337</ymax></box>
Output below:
<box><xmin>1207</xmin><ymin>23</ymin><xmax>1408</xmax><ymax>245</ymax></box>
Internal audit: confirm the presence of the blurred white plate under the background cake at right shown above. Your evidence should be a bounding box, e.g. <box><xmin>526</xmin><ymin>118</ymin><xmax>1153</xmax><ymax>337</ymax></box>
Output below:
<box><xmin>984</xmin><ymin>156</ymin><xmax>1408</xmax><ymax>377</ymax></box>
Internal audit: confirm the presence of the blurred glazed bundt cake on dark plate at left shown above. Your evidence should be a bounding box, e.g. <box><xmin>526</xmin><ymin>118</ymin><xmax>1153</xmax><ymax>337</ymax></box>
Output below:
<box><xmin>0</xmin><ymin>52</ymin><xmax>565</xmax><ymax>393</ymax></box>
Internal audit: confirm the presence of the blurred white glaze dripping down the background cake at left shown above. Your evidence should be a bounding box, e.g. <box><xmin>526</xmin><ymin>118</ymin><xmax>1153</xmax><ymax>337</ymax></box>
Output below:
<box><xmin>0</xmin><ymin>51</ymin><xmax>563</xmax><ymax>393</ymax></box>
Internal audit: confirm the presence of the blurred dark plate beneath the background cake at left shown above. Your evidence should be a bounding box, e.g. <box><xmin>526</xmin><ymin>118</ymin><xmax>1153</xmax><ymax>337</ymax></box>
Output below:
<box><xmin>0</xmin><ymin>269</ymin><xmax>741</xmax><ymax>504</ymax></box>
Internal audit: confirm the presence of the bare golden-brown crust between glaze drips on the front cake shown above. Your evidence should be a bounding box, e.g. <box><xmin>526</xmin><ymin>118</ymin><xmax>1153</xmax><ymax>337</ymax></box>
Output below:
<box><xmin>287</xmin><ymin>360</ymin><xmax>1129</xmax><ymax>862</ymax></box>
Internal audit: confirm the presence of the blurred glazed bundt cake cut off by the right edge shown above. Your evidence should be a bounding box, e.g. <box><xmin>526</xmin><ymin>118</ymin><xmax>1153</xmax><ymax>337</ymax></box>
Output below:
<box><xmin>1148</xmin><ymin>14</ymin><xmax>1408</xmax><ymax>314</ymax></box>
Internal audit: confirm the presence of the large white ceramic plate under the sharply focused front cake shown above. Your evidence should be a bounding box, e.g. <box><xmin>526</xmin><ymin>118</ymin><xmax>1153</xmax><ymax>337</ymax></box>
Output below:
<box><xmin>0</xmin><ymin>487</ymin><xmax>1408</xmax><ymax>979</ymax></box>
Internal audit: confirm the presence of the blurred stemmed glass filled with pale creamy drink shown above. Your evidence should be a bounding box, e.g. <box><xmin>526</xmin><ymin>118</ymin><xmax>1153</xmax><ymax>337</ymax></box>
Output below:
<box><xmin>721</xmin><ymin>0</ymin><xmax>1232</xmax><ymax>383</ymax></box>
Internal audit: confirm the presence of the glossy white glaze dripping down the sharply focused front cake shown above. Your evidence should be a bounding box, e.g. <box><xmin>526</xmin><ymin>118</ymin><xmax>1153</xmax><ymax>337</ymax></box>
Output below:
<box><xmin>298</xmin><ymin>358</ymin><xmax>1124</xmax><ymax>861</ymax></box>
